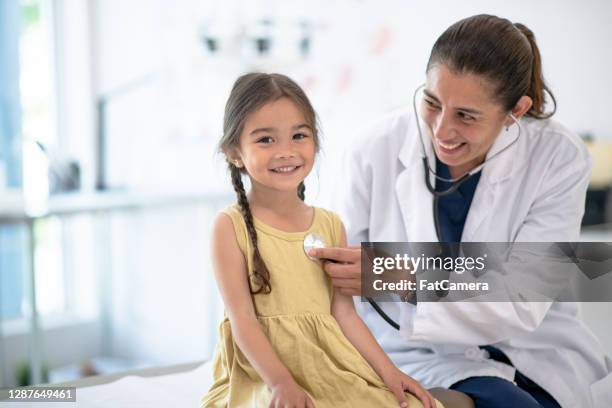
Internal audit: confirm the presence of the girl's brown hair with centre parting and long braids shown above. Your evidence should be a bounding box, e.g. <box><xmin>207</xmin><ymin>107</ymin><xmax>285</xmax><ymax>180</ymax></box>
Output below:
<box><xmin>219</xmin><ymin>73</ymin><xmax>320</xmax><ymax>294</ymax></box>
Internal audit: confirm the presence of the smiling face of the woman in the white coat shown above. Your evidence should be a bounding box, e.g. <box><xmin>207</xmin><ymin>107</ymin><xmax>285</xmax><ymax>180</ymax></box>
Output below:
<box><xmin>421</xmin><ymin>64</ymin><xmax>508</xmax><ymax>177</ymax></box>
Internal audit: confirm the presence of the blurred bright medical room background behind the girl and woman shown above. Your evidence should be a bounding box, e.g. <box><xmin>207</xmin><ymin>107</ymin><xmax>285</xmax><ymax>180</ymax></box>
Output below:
<box><xmin>0</xmin><ymin>0</ymin><xmax>612</xmax><ymax>388</ymax></box>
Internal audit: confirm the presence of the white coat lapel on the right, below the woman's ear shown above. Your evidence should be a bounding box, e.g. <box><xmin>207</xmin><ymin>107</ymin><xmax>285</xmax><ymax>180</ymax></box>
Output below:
<box><xmin>461</xmin><ymin>127</ymin><xmax>521</xmax><ymax>242</ymax></box>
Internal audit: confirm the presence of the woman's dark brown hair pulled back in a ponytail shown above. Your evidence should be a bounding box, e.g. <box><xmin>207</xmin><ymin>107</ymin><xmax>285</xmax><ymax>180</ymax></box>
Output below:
<box><xmin>427</xmin><ymin>14</ymin><xmax>557</xmax><ymax>119</ymax></box>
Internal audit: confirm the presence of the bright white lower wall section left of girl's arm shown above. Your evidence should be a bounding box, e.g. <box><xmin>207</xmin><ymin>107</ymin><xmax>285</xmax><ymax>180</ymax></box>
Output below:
<box><xmin>102</xmin><ymin>200</ymin><xmax>229</xmax><ymax>365</ymax></box>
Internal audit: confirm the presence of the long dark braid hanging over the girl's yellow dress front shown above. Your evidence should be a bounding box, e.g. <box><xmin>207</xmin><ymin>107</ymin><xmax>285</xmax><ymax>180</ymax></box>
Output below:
<box><xmin>229</xmin><ymin>163</ymin><xmax>272</xmax><ymax>295</ymax></box>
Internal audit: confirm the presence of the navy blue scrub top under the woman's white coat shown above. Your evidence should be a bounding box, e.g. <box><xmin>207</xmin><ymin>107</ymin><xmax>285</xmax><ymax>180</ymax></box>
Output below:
<box><xmin>436</xmin><ymin>157</ymin><xmax>481</xmax><ymax>242</ymax></box>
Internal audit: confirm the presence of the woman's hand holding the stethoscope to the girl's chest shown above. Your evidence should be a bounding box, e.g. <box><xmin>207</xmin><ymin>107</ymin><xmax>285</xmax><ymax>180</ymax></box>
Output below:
<box><xmin>308</xmin><ymin>246</ymin><xmax>361</xmax><ymax>296</ymax></box>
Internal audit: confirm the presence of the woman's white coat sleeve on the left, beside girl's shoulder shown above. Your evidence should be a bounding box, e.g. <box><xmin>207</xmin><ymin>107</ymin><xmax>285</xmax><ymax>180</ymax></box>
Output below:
<box><xmin>337</xmin><ymin>143</ymin><xmax>372</xmax><ymax>245</ymax></box>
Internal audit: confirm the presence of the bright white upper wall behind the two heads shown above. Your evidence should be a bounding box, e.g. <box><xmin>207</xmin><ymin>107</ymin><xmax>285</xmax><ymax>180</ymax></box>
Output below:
<box><xmin>85</xmin><ymin>0</ymin><xmax>612</xmax><ymax>198</ymax></box>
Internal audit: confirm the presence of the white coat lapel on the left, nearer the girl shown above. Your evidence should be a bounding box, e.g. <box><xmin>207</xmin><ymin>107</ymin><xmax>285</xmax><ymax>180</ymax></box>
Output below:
<box><xmin>395</xmin><ymin>122</ymin><xmax>438</xmax><ymax>242</ymax></box>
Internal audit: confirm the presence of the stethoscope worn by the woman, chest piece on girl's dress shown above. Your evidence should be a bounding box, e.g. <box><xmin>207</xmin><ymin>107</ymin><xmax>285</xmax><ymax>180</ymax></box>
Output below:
<box><xmin>304</xmin><ymin>84</ymin><xmax>522</xmax><ymax>330</ymax></box>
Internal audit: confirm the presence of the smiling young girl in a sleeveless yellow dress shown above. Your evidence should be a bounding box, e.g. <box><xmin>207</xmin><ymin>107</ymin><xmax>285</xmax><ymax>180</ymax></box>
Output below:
<box><xmin>202</xmin><ymin>74</ymin><xmax>442</xmax><ymax>408</ymax></box>
